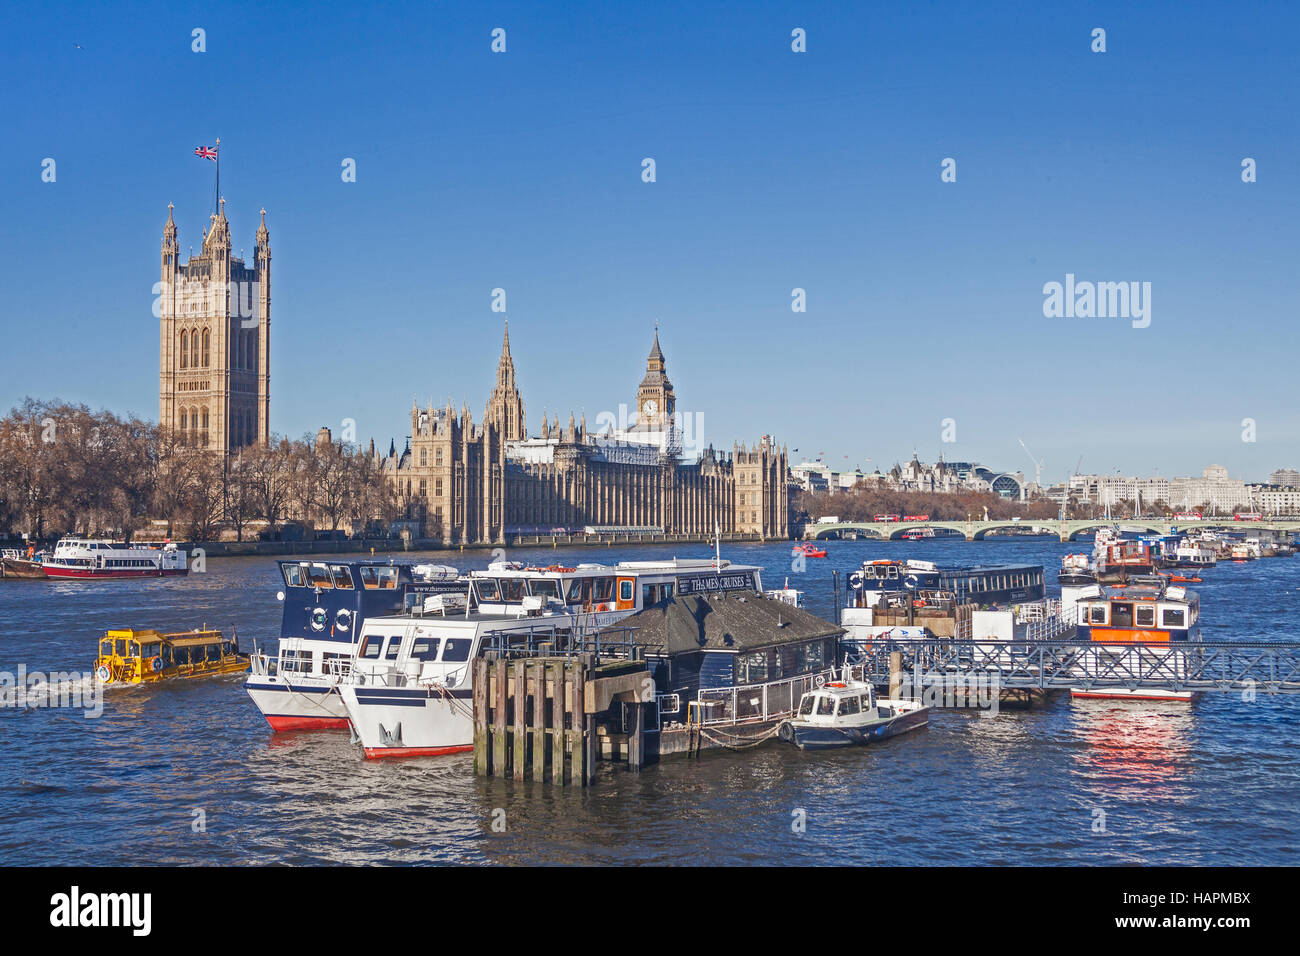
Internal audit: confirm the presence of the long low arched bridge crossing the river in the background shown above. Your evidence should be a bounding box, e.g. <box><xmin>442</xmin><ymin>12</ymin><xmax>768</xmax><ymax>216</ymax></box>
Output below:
<box><xmin>803</xmin><ymin>518</ymin><xmax>1300</xmax><ymax>541</ymax></box>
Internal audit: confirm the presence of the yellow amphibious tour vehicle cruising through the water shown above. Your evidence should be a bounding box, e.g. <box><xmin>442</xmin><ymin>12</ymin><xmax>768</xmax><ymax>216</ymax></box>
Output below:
<box><xmin>95</xmin><ymin>628</ymin><xmax>248</xmax><ymax>684</ymax></box>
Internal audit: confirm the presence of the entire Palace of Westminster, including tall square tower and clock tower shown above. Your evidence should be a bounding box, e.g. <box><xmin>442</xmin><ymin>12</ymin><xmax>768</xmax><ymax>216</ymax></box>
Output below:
<box><xmin>159</xmin><ymin>200</ymin><xmax>790</xmax><ymax>546</ymax></box>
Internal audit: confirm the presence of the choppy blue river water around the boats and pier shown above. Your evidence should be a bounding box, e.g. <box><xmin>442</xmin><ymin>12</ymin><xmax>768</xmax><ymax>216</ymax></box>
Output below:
<box><xmin>0</xmin><ymin>538</ymin><xmax>1300</xmax><ymax>865</ymax></box>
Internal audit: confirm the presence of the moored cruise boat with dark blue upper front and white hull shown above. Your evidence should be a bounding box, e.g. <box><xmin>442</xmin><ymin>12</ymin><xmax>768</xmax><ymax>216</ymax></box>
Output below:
<box><xmin>244</xmin><ymin>561</ymin><xmax>468</xmax><ymax>731</ymax></box>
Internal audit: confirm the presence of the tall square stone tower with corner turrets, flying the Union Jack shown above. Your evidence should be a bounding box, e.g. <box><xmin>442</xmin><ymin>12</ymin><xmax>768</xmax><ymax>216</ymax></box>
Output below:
<box><xmin>159</xmin><ymin>199</ymin><xmax>270</xmax><ymax>454</ymax></box>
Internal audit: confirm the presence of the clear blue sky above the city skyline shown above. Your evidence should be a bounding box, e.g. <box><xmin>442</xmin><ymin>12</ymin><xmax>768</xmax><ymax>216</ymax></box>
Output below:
<box><xmin>0</xmin><ymin>3</ymin><xmax>1300</xmax><ymax>480</ymax></box>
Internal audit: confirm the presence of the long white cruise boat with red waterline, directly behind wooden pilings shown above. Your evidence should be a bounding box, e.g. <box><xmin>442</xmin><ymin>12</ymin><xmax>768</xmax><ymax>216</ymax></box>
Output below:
<box><xmin>333</xmin><ymin>559</ymin><xmax>763</xmax><ymax>758</ymax></box>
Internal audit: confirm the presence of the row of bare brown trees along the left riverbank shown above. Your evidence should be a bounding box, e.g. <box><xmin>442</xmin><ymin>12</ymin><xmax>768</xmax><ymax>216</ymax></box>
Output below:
<box><xmin>0</xmin><ymin>398</ymin><xmax>411</xmax><ymax>541</ymax></box>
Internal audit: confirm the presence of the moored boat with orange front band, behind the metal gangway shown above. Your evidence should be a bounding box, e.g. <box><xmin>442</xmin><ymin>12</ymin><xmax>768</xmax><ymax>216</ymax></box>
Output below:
<box><xmin>1070</xmin><ymin>575</ymin><xmax>1201</xmax><ymax>701</ymax></box>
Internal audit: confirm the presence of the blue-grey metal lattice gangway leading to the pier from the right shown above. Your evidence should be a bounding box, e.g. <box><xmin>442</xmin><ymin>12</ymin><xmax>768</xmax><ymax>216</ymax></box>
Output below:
<box><xmin>845</xmin><ymin>637</ymin><xmax>1300</xmax><ymax>693</ymax></box>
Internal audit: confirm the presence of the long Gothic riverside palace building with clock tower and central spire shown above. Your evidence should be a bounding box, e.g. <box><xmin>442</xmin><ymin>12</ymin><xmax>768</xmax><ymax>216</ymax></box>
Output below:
<box><xmin>381</xmin><ymin>329</ymin><xmax>789</xmax><ymax>546</ymax></box>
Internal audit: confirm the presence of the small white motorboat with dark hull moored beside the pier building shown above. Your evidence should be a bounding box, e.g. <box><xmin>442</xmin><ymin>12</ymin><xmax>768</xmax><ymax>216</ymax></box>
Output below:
<box><xmin>777</xmin><ymin>669</ymin><xmax>930</xmax><ymax>750</ymax></box>
